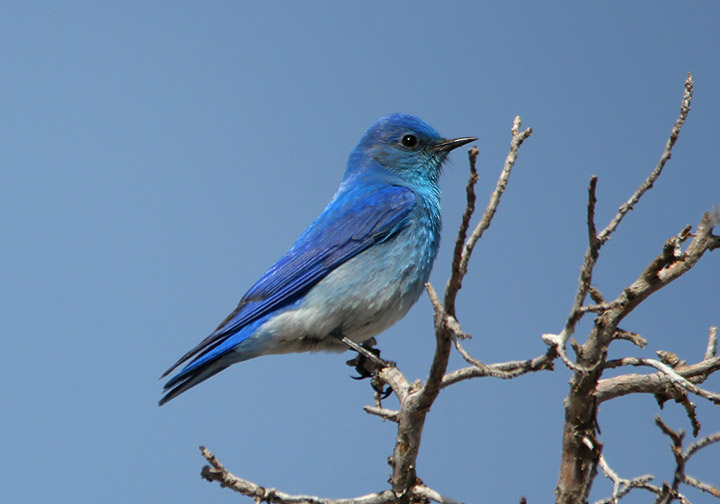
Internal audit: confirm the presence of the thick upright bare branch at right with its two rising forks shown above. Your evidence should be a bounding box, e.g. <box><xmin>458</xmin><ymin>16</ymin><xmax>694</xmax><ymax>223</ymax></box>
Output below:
<box><xmin>556</xmin><ymin>75</ymin><xmax>704</xmax><ymax>504</ymax></box>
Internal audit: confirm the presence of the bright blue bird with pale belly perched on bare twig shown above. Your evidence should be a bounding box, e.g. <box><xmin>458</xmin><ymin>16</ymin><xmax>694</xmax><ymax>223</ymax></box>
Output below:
<box><xmin>160</xmin><ymin>114</ymin><xmax>477</xmax><ymax>405</ymax></box>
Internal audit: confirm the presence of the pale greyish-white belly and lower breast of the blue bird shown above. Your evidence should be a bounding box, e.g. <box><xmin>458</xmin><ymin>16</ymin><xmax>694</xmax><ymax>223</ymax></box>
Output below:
<box><xmin>252</xmin><ymin>220</ymin><xmax>436</xmax><ymax>353</ymax></box>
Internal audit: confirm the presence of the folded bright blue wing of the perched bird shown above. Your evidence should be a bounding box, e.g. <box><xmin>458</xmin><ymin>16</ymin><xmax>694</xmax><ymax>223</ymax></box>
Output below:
<box><xmin>163</xmin><ymin>186</ymin><xmax>416</xmax><ymax>382</ymax></box>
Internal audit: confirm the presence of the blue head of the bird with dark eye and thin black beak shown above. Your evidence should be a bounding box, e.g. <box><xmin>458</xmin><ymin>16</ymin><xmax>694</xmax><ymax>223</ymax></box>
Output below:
<box><xmin>346</xmin><ymin>114</ymin><xmax>477</xmax><ymax>186</ymax></box>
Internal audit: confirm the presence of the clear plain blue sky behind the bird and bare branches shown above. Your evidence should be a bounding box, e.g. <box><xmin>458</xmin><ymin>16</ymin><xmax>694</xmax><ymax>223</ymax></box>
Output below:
<box><xmin>0</xmin><ymin>1</ymin><xmax>720</xmax><ymax>504</ymax></box>
